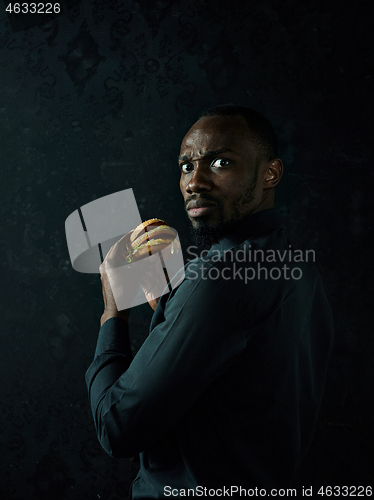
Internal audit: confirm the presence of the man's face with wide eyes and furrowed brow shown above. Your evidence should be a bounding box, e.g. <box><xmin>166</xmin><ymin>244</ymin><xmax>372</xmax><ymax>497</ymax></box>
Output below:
<box><xmin>179</xmin><ymin>116</ymin><xmax>262</xmax><ymax>244</ymax></box>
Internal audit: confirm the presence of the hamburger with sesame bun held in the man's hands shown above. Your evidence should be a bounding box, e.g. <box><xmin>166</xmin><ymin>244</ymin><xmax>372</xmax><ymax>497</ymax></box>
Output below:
<box><xmin>125</xmin><ymin>219</ymin><xmax>180</xmax><ymax>263</ymax></box>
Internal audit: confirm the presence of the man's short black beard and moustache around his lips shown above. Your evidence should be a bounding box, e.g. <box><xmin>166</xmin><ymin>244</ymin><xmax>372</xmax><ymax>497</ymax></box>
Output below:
<box><xmin>188</xmin><ymin>177</ymin><xmax>257</xmax><ymax>248</ymax></box>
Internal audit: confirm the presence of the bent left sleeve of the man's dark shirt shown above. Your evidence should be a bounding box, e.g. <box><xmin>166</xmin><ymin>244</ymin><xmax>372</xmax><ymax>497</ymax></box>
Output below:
<box><xmin>86</xmin><ymin>260</ymin><xmax>262</xmax><ymax>457</ymax></box>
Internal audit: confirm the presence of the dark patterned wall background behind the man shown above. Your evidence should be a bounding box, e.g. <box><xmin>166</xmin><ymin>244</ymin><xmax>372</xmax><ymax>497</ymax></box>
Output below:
<box><xmin>0</xmin><ymin>0</ymin><xmax>374</xmax><ymax>500</ymax></box>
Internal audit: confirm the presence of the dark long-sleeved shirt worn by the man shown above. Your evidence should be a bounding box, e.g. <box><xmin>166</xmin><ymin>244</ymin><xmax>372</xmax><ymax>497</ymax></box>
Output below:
<box><xmin>86</xmin><ymin>210</ymin><xmax>333</xmax><ymax>499</ymax></box>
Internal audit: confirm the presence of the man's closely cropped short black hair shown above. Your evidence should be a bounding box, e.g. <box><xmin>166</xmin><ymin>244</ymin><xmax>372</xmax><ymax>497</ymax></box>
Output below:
<box><xmin>199</xmin><ymin>104</ymin><xmax>278</xmax><ymax>161</ymax></box>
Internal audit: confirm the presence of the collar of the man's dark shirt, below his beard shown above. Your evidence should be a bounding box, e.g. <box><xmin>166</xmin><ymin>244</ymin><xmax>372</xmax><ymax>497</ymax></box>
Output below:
<box><xmin>208</xmin><ymin>208</ymin><xmax>284</xmax><ymax>255</ymax></box>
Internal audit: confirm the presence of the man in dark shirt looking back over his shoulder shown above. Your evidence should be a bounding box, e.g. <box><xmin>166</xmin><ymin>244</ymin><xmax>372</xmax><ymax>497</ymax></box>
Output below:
<box><xmin>86</xmin><ymin>106</ymin><xmax>332</xmax><ymax>499</ymax></box>
